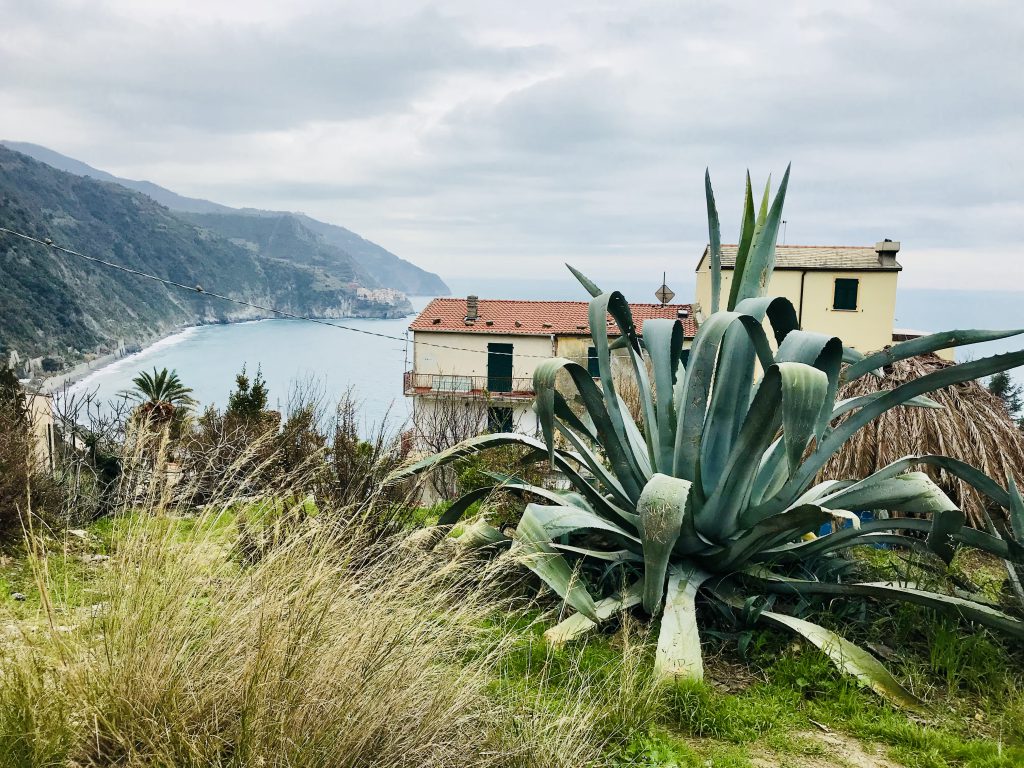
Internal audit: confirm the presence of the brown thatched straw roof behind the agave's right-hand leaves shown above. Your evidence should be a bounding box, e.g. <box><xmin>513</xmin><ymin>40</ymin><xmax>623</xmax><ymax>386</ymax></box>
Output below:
<box><xmin>821</xmin><ymin>354</ymin><xmax>1024</xmax><ymax>529</ymax></box>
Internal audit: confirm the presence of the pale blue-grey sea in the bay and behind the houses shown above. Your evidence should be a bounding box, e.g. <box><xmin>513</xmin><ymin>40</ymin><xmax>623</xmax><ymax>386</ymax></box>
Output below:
<box><xmin>61</xmin><ymin>278</ymin><xmax>1024</xmax><ymax>434</ymax></box>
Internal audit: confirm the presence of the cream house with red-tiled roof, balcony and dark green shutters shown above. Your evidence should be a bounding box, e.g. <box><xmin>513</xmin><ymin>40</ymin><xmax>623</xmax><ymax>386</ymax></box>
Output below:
<box><xmin>404</xmin><ymin>296</ymin><xmax>696</xmax><ymax>436</ymax></box>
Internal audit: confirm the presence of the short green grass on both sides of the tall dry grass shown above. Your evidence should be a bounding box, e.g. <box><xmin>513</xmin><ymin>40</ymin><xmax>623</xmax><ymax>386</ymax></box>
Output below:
<box><xmin>0</xmin><ymin>514</ymin><xmax>1024</xmax><ymax>768</ymax></box>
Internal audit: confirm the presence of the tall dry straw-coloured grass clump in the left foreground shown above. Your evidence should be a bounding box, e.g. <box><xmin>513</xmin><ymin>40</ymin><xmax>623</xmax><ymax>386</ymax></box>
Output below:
<box><xmin>0</xmin><ymin>430</ymin><xmax>654</xmax><ymax>767</ymax></box>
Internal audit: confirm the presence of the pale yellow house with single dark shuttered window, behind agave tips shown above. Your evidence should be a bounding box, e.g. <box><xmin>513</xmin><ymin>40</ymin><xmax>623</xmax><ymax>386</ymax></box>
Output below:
<box><xmin>695</xmin><ymin>240</ymin><xmax>903</xmax><ymax>352</ymax></box>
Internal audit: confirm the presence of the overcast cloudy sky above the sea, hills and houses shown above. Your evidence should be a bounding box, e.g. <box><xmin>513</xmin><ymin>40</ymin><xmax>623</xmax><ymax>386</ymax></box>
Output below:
<box><xmin>0</xmin><ymin>0</ymin><xmax>1024</xmax><ymax>289</ymax></box>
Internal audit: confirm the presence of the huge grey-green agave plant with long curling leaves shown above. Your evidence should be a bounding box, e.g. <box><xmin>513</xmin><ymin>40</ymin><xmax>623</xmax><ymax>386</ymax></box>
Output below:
<box><xmin>401</xmin><ymin>169</ymin><xmax>1024</xmax><ymax>706</ymax></box>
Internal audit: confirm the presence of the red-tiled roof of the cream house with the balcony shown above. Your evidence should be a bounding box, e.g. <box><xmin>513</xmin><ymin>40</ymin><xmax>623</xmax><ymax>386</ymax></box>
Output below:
<box><xmin>409</xmin><ymin>299</ymin><xmax>697</xmax><ymax>338</ymax></box>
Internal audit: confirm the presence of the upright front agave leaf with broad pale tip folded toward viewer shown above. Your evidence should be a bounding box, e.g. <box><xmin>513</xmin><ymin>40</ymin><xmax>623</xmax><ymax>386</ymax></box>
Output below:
<box><xmin>637</xmin><ymin>474</ymin><xmax>691</xmax><ymax>615</ymax></box>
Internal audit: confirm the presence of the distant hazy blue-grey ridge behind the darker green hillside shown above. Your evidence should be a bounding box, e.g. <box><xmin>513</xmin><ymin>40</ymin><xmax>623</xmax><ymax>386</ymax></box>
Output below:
<box><xmin>0</xmin><ymin>141</ymin><xmax>450</xmax><ymax>296</ymax></box>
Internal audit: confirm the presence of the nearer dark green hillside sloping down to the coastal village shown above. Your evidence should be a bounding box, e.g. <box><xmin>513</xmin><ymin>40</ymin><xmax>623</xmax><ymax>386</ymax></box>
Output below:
<box><xmin>0</xmin><ymin>147</ymin><xmax>411</xmax><ymax>372</ymax></box>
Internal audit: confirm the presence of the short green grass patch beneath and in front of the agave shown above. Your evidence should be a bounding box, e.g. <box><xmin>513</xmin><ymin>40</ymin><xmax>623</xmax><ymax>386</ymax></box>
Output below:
<box><xmin>473</xmin><ymin>598</ymin><xmax>1024</xmax><ymax>768</ymax></box>
